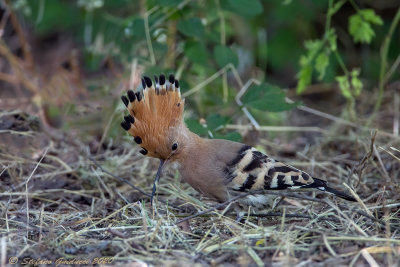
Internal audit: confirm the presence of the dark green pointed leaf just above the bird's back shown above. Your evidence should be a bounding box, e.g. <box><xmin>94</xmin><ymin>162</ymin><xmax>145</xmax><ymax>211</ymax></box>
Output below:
<box><xmin>242</xmin><ymin>84</ymin><xmax>299</xmax><ymax>112</ymax></box>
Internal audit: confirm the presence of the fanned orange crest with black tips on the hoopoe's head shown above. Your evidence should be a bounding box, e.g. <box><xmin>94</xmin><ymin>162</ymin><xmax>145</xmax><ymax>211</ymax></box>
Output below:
<box><xmin>121</xmin><ymin>74</ymin><xmax>185</xmax><ymax>158</ymax></box>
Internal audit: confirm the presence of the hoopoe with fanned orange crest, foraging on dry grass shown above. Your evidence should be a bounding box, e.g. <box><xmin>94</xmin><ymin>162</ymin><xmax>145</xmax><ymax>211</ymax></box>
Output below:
<box><xmin>121</xmin><ymin>74</ymin><xmax>356</xmax><ymax>216</ymax></box>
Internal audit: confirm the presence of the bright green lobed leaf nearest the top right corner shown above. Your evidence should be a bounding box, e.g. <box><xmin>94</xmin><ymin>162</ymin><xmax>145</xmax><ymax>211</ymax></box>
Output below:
<box><xmin>349</xmin><ymin>9</ymin><xmax>383</xmax><ymax>44</ymax></box>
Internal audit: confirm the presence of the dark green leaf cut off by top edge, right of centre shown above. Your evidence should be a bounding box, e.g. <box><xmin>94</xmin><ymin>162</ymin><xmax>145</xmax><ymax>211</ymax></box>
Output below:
<box><xmin>221</xmin><ymin>0</ymin><xmax>263</xmax><ymax>16</ymax></box>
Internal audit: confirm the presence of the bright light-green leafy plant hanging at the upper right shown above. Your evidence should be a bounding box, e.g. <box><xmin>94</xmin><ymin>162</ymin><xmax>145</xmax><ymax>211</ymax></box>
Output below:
<box><xmin>297</xmin><ymin>0</ymin><xmax>383</xmax><ymax>120</ymax></box>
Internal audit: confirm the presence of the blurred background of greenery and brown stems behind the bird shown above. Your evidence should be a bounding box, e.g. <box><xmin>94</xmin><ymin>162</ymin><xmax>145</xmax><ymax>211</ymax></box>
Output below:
<box><xmin>0</xmin><ymin>0</ymin><xmax>400</xmax><ymax>147</ymax></box>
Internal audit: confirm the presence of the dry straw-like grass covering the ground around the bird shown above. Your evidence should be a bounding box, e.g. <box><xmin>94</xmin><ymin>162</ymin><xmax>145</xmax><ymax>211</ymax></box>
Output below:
<box><xmin>0</xmin><ymin>100</ymin><xmax>400</xmax><ymax>266</ymax></box>
